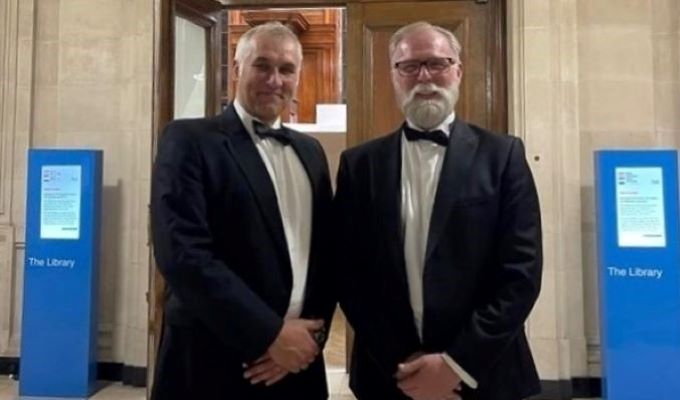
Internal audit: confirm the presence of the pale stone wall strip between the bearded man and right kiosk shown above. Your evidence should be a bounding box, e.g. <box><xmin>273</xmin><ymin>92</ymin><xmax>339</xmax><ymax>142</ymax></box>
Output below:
<box><xmin>507</xmin><ymin>0</ymin><xmax>588</xmax><ymax>382</ymax></box>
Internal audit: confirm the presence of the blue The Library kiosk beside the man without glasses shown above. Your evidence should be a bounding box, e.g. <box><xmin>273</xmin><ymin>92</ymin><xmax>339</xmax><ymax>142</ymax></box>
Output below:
<box><xmin>19</xmin><ymin>150</ymin><xmax>102</xmax><ymax>398</ymax></box>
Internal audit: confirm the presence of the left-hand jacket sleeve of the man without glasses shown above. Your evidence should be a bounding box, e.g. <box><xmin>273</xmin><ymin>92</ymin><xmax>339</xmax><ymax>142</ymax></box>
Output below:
<box><xmin>151</xmin><ymin>122</ymin><xmax>283</xmax><ymax>362</ymax></box>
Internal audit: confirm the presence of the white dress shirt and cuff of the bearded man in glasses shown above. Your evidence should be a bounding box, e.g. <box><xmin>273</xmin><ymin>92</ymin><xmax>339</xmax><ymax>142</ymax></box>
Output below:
<box><xmin>401</xmin><ymin>113</ymin><xmax>477</xmax><ymax>388</ymax></box>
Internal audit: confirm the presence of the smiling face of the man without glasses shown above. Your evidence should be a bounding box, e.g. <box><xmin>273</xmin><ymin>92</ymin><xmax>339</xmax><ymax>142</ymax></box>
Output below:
<box><xmin>234</xmin><ymin>33</ymin><xmax>302</xmax><ymax>123</ymax></box>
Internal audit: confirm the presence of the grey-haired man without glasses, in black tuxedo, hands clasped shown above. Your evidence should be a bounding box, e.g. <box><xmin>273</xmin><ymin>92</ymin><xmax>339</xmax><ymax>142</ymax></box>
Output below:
<box><xmin>151</xmin><ymin>22</ymin><xmax>335</xmax><ymax>400</ymax></box>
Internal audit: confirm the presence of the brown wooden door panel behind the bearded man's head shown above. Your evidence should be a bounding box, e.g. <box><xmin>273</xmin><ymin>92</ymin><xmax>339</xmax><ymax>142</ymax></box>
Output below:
<box><xmin>347</xmin><ymin>0</ymin><xmax>507</xmax><ymax>145</ymax></box>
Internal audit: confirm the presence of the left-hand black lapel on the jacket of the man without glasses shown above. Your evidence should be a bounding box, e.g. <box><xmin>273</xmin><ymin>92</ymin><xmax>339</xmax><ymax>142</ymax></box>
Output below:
<box><xmin>220</xmin><ymin>104</ymin><xmax>292</xmax><ymax>276</ymax></box>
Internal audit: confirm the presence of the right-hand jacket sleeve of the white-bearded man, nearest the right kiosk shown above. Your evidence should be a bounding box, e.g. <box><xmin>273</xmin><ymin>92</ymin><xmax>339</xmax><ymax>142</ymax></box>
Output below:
<box><xmin>447</xmin><ymin>138</ymin><xmax>542</xmax><ymax>379</ymax></box>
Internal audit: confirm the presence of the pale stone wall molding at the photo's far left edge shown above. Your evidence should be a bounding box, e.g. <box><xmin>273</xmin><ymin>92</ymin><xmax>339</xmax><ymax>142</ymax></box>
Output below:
<box><xmin>0</xmin><ymin>0</ymin><xmax>35</xmax><ymax>356</ymax></box>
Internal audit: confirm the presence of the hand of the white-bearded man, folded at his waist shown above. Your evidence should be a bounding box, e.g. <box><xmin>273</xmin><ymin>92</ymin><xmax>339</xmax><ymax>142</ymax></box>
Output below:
<box><xmin>396</xmin><ymin>354</ymin><xmax>461</xmax><ymax>400</ymax></box>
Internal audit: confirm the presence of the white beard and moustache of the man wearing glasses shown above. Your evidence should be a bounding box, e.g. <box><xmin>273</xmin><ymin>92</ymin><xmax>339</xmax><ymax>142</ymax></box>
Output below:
<box><xmin>401</xmin><ymin>83</ymin><xmax>458</xmax><ymax>130</ymax></box>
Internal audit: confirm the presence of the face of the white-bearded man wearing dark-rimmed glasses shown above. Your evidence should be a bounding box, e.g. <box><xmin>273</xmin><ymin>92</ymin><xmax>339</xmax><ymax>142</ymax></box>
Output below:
<box><xmin>391</xmin><ymin>29</ymin><xmax>463</xmax><ymax>130</ymax></box>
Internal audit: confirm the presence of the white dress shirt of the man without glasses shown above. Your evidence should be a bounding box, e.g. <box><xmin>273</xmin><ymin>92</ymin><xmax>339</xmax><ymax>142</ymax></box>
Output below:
<box><xmin>234</xmin><ymin>101</ymin><xmax>312</xmax><ymax>318</ymax></box>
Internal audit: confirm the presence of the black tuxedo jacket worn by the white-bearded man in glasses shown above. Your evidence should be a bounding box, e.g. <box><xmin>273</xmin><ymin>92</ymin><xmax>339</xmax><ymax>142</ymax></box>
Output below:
<box><xmin>334</xmin><ymin>119</ymin><xmax>542</xmax><ymax>400</ymax></box>
